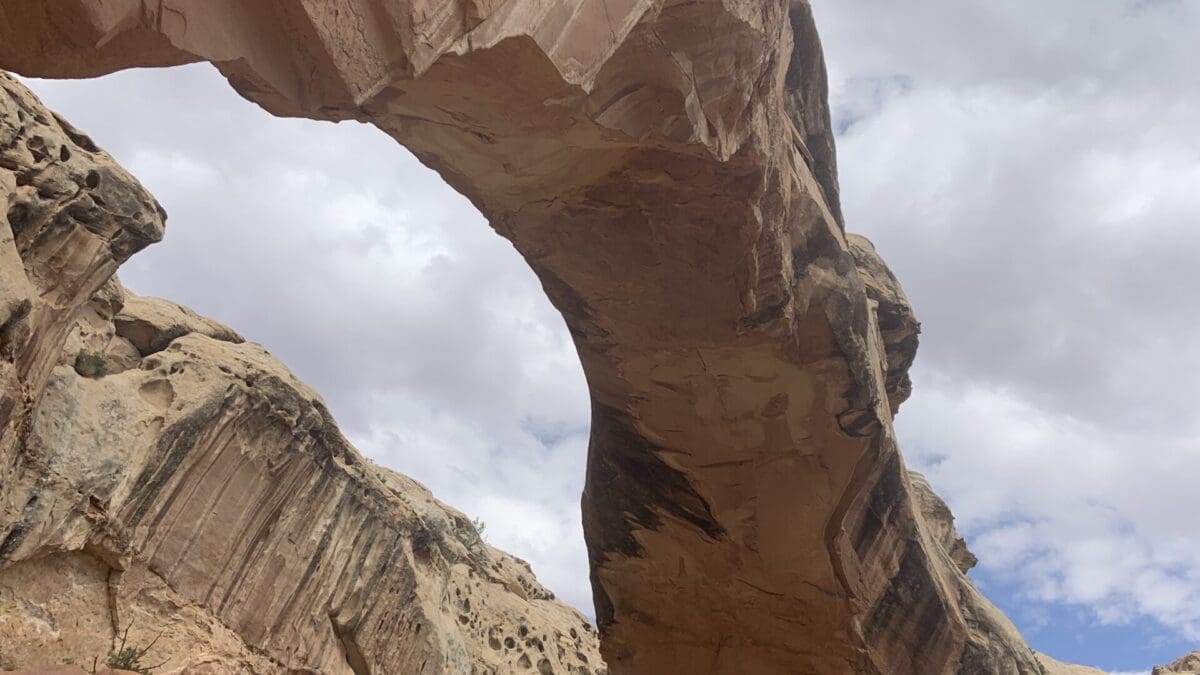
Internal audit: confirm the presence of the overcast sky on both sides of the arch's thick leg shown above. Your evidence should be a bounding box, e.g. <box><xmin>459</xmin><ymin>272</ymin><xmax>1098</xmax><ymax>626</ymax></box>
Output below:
<box><xmin>18</xmin><ymin>0</ymin><xmax>1200</xmax><ymax>671</ymax></box>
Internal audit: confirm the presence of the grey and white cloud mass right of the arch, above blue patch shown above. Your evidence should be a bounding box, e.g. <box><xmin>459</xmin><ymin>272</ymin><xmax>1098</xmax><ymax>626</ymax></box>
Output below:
<box><xmin>817</xmin><ymin>0</ymin><xmax>1200</xmax><ymax>653</ymax></box>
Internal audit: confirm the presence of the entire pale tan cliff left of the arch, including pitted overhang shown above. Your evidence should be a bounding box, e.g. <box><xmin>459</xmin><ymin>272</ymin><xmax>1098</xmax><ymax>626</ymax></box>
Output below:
<box><xmin>0</xmin><ymin>70</ymin><xmax>605</xmax><ymax>675</ymax></box>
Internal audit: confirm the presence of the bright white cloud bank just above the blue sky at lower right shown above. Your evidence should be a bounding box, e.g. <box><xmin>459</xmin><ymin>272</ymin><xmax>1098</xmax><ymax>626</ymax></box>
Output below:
<box><xmin>899</xmin><ymin>371</ymin><xmax>1200</xmax><ymax>640</ymax></box>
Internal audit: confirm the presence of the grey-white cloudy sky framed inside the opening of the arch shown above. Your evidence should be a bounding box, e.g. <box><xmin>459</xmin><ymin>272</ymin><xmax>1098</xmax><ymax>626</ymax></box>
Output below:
<box><xmin>23</xmin><ymin>65</ymin><xmax>590</xmax><ymax>611</ymax></box>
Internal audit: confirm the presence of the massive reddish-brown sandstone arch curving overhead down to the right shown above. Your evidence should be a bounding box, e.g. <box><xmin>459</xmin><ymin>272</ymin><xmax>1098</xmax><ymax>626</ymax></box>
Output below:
<box><xmin>0</xmin><ymin>0</ymin><xmax>1038</xmax><ymax>675</ymax></box>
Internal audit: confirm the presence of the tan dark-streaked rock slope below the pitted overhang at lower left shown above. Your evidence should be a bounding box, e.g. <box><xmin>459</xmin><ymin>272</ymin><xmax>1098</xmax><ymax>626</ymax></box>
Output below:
<box><xmin>0</xmin><ymin>319</ymin><xmax>604</xmax><ymax>675</ymax></box>
